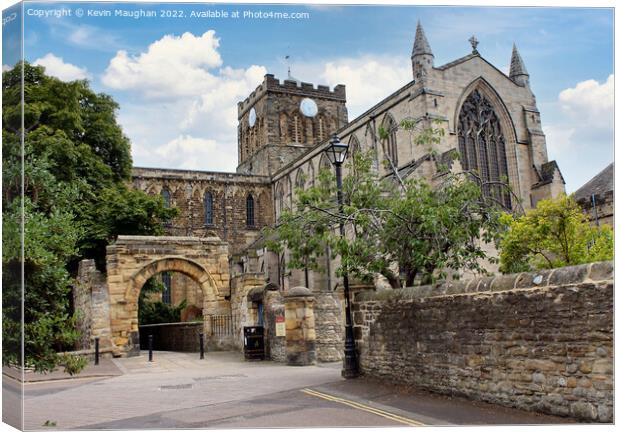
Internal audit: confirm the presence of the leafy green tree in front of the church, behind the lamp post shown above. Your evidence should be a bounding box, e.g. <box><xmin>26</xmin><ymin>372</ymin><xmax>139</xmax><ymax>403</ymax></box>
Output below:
<box><xmin>267</xmin><ymin>126</ymin><xmax>500</xmax><ymax>288</ymax></box>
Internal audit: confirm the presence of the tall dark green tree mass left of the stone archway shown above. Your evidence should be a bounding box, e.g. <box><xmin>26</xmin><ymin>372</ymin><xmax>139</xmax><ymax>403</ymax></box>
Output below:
<box><xmin>2</xmin><ymin>63</ymin><xmax>176</xmax><ymax>372</ymax></box>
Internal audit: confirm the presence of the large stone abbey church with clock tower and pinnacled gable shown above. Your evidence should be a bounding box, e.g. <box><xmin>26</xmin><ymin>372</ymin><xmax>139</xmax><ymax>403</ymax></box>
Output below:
<box><xmin>122</xmin><ymin>23</ymin><xmax>564</xmax><ymax>360</ymax></box>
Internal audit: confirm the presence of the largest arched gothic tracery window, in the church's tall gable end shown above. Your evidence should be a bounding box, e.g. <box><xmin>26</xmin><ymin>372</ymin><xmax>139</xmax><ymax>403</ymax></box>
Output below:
<box><xmin>458</xmin><ymin>90</ymin><xmax>511</xmax><ymax>209</ymax></box>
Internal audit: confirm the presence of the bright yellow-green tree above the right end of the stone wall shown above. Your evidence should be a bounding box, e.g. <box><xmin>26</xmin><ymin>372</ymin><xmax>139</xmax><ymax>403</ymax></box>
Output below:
<box><xmin>500</xmin><ymin>195</ymin><xmax>613</xmax><ymax>273</ymax></box>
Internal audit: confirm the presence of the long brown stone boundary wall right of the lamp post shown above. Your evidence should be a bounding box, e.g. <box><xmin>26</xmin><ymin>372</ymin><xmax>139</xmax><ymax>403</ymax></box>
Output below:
<box><xmin>353</xmin><ymin>262</ymin><xmax>614</xmax><ymax>422</ymax></box>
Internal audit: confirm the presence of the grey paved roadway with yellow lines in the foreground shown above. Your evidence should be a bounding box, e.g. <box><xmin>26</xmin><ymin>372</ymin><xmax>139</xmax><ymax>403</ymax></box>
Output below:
<box><xmin>3</xmin><ymin>352</ymin><xmax>572</xmax><ymax>430</ymax></box>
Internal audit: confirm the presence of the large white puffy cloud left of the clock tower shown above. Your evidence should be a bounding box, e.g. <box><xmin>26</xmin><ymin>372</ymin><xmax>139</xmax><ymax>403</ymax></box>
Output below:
<box><xmin>101</xmin><ymin>30</ymin><xmax>267</xmax><ymax>171</ymax></box>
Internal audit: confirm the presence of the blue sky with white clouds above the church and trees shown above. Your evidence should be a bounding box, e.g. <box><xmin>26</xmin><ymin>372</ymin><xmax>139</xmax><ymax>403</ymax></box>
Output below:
<box><xmin>3</xmin><ymin>2</ymin><xmax>614</xmax><ymax>192</ymax></box>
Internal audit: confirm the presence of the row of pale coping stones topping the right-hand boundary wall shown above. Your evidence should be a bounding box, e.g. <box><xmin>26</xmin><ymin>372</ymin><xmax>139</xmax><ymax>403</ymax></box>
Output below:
<box><xmin>355</xmin><ymin>261</ymin><xmax>614</xmax><ymax>302</ymax></box>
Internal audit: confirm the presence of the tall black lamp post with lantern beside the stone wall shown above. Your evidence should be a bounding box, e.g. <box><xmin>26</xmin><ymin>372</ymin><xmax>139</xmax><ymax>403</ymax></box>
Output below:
<box><xmin>325</xmin><ymin>135</ymin><xmax>359</xmax><ymax>378</ymax></box>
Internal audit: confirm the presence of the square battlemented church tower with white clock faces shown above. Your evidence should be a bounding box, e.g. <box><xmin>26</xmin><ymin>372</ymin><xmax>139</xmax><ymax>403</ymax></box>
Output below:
<box><xmin>237</xmin><ymin>74</ymin><xmax>348</xmax><ymax>176</ymax></box>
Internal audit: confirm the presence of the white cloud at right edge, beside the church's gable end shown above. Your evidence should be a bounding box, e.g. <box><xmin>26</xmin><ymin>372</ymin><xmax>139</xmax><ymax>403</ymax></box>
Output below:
<box><xmin>544</xmin><ymin>75</ymin><xmax>614</xmax><ymax>193</ymax></box>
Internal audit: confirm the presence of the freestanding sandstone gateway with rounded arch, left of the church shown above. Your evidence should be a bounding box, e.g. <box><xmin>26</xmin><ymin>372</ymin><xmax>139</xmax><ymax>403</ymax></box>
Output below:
<box><xmin>106</xmin><ymin>236</ymin><xmax>230</xmax><ymax>355</ymax></box>
